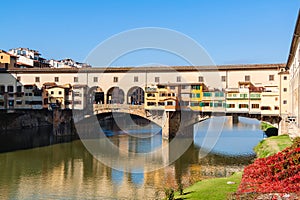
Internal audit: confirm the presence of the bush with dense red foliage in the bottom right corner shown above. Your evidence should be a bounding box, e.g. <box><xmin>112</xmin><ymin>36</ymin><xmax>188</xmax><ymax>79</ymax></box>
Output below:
<box><xmin>237</xmin><ymin>138</ymin><xmax>300</xmax><ymax>194</ymax></box>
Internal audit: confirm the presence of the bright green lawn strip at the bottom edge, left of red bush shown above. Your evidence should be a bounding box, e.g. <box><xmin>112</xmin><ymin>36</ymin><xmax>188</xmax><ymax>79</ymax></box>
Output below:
<box><xmin>175</xmin><ymin>172</ymin><xmax>242</xmax><ymax>200</ymax></box>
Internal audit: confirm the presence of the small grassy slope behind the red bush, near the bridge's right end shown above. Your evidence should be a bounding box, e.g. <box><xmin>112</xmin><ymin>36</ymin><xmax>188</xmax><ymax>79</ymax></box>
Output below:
<box><xmin>254</xmin><ymin>135</ymin><xmax>292</xmax><ymax>158</ymax></box>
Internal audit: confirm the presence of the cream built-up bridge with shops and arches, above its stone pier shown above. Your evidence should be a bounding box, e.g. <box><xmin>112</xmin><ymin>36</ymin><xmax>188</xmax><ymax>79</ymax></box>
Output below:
<box><xmin>0</xmin><ymin>64</ymin><xmax>289</xmax><ymax>138</ymax></box>
